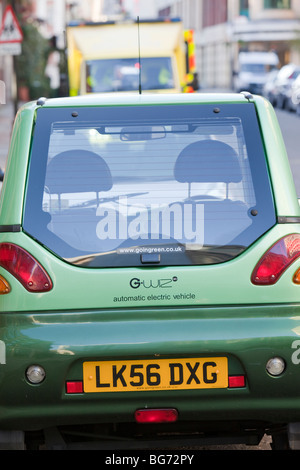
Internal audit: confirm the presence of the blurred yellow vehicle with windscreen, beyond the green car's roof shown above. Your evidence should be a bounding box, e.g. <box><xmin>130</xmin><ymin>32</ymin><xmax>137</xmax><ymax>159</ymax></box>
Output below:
<box><xmin>67</xmin><ymin>19</ymin><xmax>197</xmax><ymax>96</ymax></box>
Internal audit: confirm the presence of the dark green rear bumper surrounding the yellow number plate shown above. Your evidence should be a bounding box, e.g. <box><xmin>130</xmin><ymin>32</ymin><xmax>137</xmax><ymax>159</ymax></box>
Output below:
<box><xmin>0</xmin><ymin>305</ymin><xmax>300</xmax><ymax>430</ymax></box>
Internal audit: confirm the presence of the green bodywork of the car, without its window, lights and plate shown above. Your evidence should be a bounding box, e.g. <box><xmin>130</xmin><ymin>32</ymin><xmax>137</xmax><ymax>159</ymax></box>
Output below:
<box><xmin>0</xmin><ymin>94</ymin><xmax>300</xmax><ymax>448</ymax></box>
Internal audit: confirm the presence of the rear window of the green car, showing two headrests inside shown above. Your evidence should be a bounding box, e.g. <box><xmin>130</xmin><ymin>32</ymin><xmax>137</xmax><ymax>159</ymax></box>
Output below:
<box><xmin>23</xmin><ymin>103</ymin><xmax>275</xmax><ymax>267</ymax></box>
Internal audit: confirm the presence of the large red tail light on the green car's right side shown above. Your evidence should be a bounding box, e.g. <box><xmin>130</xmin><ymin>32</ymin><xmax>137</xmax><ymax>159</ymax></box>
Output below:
<box><xmin>251</xmin><ymin>234</ymin><xmax>300</xmax><ymax>285</ymax></box>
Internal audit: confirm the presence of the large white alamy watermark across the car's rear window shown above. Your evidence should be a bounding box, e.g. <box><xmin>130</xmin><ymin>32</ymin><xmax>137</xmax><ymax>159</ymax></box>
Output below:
<box><xmin>96</xmin><ymin>197</ymin><xmax>204</xmax><ymax>250</ymax></box>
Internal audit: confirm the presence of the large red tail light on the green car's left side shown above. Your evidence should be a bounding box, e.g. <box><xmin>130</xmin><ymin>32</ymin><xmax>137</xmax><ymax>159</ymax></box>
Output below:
<box><xmin>0</xmin><ymin>243</ymin><xmax>52</xmax><ymax>292</ymax></box>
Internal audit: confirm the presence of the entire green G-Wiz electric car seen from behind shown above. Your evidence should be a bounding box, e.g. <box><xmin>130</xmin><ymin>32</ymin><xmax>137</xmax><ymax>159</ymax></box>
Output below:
<box><xmin>0</xmin><ymin>93</ymin><xmax>300</xmax><ymax>449</ymax></box>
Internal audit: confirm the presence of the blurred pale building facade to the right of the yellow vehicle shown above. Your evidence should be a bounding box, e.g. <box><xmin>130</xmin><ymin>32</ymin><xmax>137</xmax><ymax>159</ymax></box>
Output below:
<box><xmin>156</xmin><ymin>0</ymin><xmax>300</xmax><ymax>89</ymax></box>
